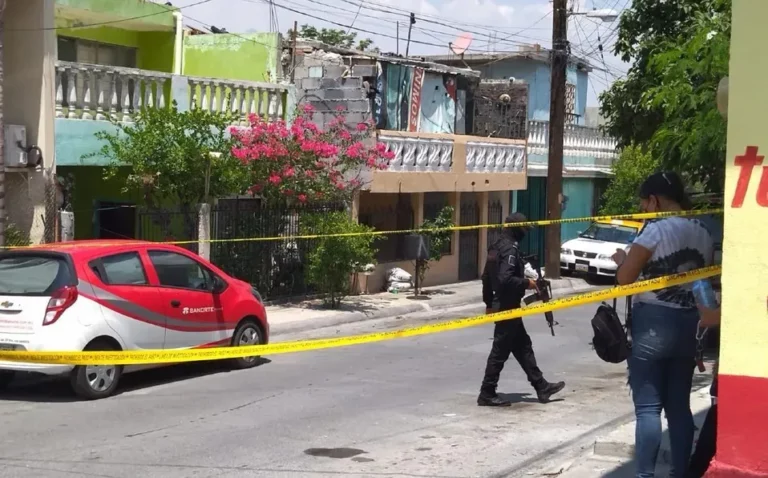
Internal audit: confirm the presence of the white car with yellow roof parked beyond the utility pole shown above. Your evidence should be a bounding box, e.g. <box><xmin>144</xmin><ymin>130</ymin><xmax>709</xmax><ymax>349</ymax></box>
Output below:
<box><xmin>560</xmin><ymin>220</ymin><xmax>643</xmax><ymax>277</ymax></box>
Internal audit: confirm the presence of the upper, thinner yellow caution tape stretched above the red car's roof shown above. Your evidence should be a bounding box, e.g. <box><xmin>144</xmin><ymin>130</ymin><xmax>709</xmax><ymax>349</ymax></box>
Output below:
<box><xmin>0</xmin><ymin>209</ymin><xmax>723</xmax><ymax>250</ymax></box>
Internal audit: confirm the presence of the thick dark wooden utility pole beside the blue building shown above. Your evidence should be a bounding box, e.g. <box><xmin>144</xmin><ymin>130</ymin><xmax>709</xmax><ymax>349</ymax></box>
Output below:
<box><xmin>544</xmin><ymin>0</ymin><xmax>568</xmax><ymax>279</ymax></box>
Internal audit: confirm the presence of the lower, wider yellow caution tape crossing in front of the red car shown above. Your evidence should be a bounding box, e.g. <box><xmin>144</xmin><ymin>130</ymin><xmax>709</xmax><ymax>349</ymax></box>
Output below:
<box><xmin>0</xmin><ymin>266</ymin><xmax>720</xmax><ymax>365</ymax></box>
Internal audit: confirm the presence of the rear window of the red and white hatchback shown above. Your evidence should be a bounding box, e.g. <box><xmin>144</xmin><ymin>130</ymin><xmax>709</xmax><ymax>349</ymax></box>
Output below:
<box><xmin>0</xmin><ymin>254</ymin><xmax>72</xmax><ymax>296</ymax></box>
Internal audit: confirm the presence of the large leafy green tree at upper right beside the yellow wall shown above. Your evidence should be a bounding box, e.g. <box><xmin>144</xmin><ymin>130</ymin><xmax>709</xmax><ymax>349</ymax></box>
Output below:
<box><xmin>600</xmin><ymin>0</ymin><xmax>731</xmax><ymax>190</ymax></box>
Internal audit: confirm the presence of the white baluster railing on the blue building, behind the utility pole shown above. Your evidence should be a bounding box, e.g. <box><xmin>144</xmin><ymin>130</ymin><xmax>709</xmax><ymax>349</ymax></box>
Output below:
<box><xmin>528</xmin><ymin>121</ymin><xmax>618</xmax><ymax>166</ymax></box>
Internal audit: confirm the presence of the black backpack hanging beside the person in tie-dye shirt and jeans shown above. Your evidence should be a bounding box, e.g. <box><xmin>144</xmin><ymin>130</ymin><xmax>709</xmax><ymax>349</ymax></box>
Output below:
<box><xmin>592</xmin><ymin>297</ymin><xmax>632</xmax><ymax>363</ymax></box>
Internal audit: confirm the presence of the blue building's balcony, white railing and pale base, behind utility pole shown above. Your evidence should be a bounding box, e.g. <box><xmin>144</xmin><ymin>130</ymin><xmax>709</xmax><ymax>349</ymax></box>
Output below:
<box><xmin>528</xmin><ymin>121</ymin><xmax>618</xmax><ymax>175</ymax></box>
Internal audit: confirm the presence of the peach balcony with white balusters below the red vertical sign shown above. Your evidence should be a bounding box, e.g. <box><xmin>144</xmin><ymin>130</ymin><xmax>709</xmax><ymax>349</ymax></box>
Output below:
<box><xmin>370</xmin><ymin>131</ymin><xmax>526</xmax><ymax>193</ymax></box>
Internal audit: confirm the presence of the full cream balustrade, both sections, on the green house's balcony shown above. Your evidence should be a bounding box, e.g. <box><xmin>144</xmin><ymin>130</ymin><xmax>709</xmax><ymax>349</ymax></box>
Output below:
<box><xmin>56</xmin><ymin>61</ymin><xmax>287</xmax><ymax>122</ymax></box>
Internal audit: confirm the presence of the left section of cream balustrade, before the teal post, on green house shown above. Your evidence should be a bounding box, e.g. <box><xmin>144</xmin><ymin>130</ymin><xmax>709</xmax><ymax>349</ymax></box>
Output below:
<box><xmin>56</xmin><ymin>61</ymin><xmax>171</xmax><ymax>121</ymax></box>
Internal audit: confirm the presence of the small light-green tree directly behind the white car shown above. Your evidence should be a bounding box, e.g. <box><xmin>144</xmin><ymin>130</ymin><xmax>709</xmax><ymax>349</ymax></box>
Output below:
<box><xmin>600</xmin><ymin>145</ymin><xmax>659</xmax><ymax>215</ymax></box>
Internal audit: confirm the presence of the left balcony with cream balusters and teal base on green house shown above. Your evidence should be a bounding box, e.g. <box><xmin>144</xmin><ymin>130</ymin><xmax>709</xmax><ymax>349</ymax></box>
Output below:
<box><xmin>55</xmin><ymin>61</ymin><xmax>290</xmax><ymax>166</ymax></box>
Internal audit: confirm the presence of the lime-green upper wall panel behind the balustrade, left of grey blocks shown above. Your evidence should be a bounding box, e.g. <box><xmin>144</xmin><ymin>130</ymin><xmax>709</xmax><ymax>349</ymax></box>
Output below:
<box><xmin>184</xmin><ymin>33</ymin><xmax>278</xmax><ymax>82</ymax></box>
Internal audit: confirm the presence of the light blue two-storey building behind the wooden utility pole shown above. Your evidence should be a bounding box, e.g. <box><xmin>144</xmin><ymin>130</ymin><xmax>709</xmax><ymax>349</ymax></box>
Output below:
<box><xmin>428</xmin><ymin>45</ymin><xmax>617</xmax><ymax>254</ymax></box>
